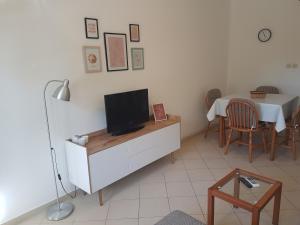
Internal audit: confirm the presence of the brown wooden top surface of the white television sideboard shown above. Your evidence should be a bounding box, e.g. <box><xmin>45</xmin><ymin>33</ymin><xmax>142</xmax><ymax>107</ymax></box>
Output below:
<box><xmin>69</xmin><ymin>115</ymin><xmax>181</xmax><ymax>155</ymax></box>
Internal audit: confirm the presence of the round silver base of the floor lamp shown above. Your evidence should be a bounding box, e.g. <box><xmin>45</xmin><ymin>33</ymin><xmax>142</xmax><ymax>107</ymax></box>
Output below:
<box><xmin>47</xmin><ymin>203</ymin><xmax>74</xmax><ymax>221</ymax></box>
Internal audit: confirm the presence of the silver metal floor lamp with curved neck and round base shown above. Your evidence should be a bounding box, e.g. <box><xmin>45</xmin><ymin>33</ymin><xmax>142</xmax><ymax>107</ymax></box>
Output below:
<box><xmin>44</xmin><ymin>80</ymin><xmax>74</xmax><ymax>221</ymax></box>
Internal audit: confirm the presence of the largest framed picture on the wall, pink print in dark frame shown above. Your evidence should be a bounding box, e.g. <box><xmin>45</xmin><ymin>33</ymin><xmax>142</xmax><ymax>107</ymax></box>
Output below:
<box><xmin>104</xmin><ymin>33</ymin><xmax>128</xmax><ymax>72</ymax></box>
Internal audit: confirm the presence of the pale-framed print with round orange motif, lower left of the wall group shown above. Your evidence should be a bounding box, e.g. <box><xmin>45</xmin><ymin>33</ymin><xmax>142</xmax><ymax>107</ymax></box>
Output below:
<box><xmin>82</xmin><ymin>46</ymin><xmax>102</xmax><ymax>73</ymax></box>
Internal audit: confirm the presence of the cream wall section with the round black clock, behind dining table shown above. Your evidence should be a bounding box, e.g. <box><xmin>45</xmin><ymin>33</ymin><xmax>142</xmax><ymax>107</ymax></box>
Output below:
<box><xmin>228</xmin><ymin>0</ymin><xmax>300</xmax><ymax>95</ymax></box>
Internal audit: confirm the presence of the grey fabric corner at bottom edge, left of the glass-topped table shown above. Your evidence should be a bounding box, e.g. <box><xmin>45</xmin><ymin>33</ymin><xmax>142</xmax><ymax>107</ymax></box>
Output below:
<box><xmin>155</xmin><ymin>210</ymin><xmax>205</xmax><ymax>225</ymax></box>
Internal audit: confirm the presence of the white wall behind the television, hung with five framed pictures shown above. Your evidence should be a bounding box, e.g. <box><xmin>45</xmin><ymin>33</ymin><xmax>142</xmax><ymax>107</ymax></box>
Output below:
<box><xmin>0</xmin><ymin>0</ymin><xmax>229</xmax><ymax>223</ymax></box>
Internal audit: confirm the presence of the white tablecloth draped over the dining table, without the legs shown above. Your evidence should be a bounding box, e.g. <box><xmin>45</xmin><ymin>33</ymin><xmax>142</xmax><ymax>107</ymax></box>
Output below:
<box><xmin>207</xmin><ymin>93</ymin><xmax>298</xmax><ymax>132</ymax></box>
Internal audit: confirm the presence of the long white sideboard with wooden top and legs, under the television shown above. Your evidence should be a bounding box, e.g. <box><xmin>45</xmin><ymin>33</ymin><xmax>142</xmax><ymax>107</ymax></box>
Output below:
<box><xmin>65</xmin><ymin>115</ymin><xmax>181</xmax><ymax>205</ymax></box>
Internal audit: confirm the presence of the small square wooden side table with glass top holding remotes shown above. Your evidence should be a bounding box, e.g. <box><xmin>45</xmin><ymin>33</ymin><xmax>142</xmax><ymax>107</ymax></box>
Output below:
<box><xmin>207</xmin><ymin>169</ymin><xmax>282</xmax><ymax>225</ymax></box>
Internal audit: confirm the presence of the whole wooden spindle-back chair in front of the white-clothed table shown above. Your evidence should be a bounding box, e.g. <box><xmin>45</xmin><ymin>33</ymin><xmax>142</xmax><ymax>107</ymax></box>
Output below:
<box><xmin>224</xmin><ymin>98</ymin><xmax>267</xmax><ymax>162</ymax></box>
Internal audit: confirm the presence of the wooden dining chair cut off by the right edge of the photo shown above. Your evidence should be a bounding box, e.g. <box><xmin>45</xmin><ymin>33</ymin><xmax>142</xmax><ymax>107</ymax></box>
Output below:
<box><xmin>279</xmin><ymin>107</ymin><xmax>300</xmax><ymax>160</ymax></box>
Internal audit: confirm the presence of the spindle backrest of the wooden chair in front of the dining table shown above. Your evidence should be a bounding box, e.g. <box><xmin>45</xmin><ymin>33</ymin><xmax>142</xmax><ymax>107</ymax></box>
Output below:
<box><xmin>226</xmin><ymin>98</ymin><xmax>258</xmax><ymax>130</ymax></box>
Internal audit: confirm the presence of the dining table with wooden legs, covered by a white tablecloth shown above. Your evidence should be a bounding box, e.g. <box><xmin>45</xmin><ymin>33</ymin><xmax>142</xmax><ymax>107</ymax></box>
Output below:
<box><xmin>207</xmin><ymin>93</ymin><xmax>298</xmax><ymax>161</ymax></box>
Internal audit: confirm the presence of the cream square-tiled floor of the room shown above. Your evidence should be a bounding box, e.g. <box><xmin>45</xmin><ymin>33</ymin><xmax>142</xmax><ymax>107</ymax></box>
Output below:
<box><xmin>15</xmin><ymin>134</ymin><xmax>300</xmax><ymax>225</ymax></box>
